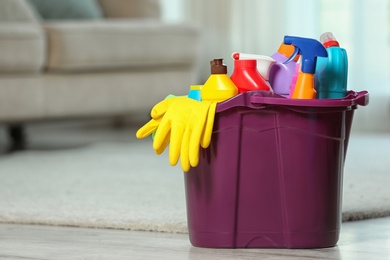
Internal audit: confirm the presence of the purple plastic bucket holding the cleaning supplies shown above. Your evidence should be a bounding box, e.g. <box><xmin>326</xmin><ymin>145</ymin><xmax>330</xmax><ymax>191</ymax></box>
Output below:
<box><xmin>184</xmin><ymin>91</ymin><xmax>368</xmax><ymax>248</ymax></box>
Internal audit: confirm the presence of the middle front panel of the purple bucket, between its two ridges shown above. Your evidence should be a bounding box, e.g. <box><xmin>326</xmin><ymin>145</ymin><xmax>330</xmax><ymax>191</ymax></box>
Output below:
<box><xmin>236</xmin><ymin>106</ymin><xmax>286</xmax><ymax>247</ymax></box>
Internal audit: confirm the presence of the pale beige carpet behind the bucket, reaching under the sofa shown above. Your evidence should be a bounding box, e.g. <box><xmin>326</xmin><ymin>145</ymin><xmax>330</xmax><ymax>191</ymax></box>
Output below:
<box><xmin>0</xmin><ymin>122</ymin><xmax>390</xmax><ymax>232</ymax></box>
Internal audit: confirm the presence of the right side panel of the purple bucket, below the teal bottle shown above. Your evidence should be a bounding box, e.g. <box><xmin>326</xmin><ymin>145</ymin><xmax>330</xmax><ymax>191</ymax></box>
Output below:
<box><xmin>279</xmin><ymin>108</ymin><xmax>347</xmax><ymax>248</ymax></box>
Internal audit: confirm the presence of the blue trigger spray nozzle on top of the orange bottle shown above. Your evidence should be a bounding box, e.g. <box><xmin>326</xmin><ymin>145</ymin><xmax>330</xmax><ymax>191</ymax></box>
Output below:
<box><xmin>284</xmin><ymin>36</ymin><xmax>328</xmax><ymax>74</ymax></box>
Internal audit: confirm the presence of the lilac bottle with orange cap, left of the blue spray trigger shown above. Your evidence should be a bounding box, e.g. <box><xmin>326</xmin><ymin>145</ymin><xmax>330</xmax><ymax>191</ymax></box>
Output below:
<box><xmin>268</xmin><ymin>43</ymin><xmax>300</xmax><ymax>97</ymax></box>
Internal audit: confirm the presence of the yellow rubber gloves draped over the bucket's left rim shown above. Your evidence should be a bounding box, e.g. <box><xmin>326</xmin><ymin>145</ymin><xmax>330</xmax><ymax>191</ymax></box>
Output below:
<box><xmin>136</xmin><ymin>97</ymin><xmax>216</xmax><ymax>172</ymax></box>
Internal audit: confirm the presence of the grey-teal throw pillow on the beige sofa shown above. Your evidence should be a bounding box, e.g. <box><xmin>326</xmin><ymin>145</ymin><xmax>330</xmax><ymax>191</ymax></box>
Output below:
<box><xmin>29</xmin><ymin>0</ymin><xmax>103</xmax><ymax>20</ymax></box>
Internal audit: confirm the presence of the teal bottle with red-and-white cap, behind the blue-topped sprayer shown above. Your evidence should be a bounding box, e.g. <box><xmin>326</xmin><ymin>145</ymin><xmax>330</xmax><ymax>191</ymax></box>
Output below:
<box><xmin>315</xmin><ymin>32</ymin><xmax>348</xmax><ymax>99</ymax></box>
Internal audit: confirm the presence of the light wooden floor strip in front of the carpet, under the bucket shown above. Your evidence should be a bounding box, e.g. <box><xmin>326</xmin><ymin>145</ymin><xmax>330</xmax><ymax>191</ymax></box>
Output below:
<box><xmin>0</xmin><ymin>218</ymin><xmax>390</xmax><ymax>260</ymax></box>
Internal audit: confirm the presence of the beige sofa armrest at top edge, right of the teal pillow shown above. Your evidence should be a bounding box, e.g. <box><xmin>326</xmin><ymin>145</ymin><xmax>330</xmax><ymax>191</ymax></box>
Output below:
<box><xmin>99</xmin><ymin>0</ymin><xmax>161</xmax><ymax>19</ymax></box>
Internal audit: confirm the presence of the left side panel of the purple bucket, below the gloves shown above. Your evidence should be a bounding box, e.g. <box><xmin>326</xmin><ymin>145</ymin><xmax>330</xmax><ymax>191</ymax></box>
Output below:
<box><xmin>184</xmin><ymin>109</ymin><xmax>241</xmax><ymax>248</ymax></box>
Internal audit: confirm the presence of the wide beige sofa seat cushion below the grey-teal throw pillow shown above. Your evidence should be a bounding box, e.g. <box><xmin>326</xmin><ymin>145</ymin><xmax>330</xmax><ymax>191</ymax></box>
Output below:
<box><xmin>44</xmin><ymin>20</ymin><xmax>199</xmax><ymax>71</ymax></box>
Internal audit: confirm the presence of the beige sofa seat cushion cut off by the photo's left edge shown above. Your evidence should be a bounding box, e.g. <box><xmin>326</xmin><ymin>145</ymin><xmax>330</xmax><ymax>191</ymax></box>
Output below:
<box><xmin>0</xmin><ymin>23</ymin><xmax>46</xmax><ymax>74</ymax></box>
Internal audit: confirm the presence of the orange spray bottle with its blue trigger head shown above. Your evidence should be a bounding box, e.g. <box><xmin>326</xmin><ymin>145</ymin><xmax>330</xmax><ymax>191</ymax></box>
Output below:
<box><xmin>284</xmin><ymin>36</ymin><xmax>328</xmax><ymax>99</ymax></box>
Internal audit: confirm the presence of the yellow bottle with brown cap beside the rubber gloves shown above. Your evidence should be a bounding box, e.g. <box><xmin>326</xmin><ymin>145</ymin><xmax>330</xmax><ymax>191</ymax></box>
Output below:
<box><xmin>201</xmin><ymin>59</ymin><xmax>238</xmax><ymax>102</ymax></box>
